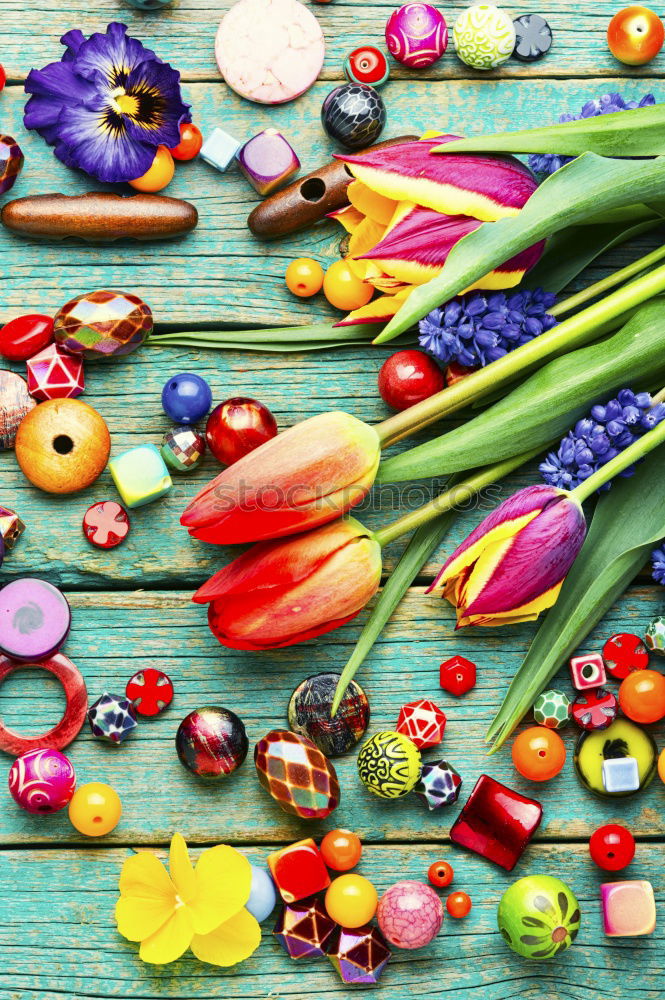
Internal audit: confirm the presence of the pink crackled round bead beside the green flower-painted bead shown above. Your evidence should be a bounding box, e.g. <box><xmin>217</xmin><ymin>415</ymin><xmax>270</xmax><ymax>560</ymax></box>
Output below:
<box><xmin>376</xmin><ymin>881</ymin><xmax>443</xmax><ymax>948</ymax></box>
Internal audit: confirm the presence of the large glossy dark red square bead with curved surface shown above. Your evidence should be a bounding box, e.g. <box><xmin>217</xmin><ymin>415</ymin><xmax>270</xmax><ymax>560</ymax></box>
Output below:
<box><xmin>450</xmin><ymin>774</ymin><xmax>543</xmax><ymax>872</ymax></box>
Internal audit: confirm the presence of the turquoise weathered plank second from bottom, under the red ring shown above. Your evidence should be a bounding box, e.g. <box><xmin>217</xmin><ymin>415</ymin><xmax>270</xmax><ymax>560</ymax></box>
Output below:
<box><xmin>0</xmin><ymin>588</ymin><xmax>665</xmax><ymax>844</ymax></box>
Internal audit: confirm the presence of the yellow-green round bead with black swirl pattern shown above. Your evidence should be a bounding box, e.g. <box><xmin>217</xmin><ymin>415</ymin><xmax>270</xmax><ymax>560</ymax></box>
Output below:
<box><xmin>358</xmin><ymin>730</ymin><xmax>422</xmax><ymax>799</ymax></box>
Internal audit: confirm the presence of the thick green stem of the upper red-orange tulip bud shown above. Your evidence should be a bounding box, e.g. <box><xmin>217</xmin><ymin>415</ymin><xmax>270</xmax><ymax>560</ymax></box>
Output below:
<box><xmin>375</xmin><ymin>265</ymin><xmax>665</xmax><ymax>448</ymax></box>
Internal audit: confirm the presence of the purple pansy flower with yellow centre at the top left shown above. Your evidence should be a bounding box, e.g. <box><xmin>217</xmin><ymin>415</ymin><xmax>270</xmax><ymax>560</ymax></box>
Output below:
<box><xmin>24</xmin><ymin>22</ymin><xmax>190</xmax><ymax>182</ymax></box>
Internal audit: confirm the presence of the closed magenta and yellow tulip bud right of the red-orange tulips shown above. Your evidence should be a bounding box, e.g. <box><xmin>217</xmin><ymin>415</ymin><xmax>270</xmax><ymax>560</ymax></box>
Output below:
<box><xmin>428</xmin><ymin>486</ymin><xmax>586</xmax><ymax>628</ymax></box>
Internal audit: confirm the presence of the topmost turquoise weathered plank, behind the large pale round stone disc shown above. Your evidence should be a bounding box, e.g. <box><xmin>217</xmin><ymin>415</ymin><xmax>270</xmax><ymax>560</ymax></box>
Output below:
<box><xmin>0</xmin><ymin>0</ymin><xmax>665</xmax><ymax>81</ymax></box>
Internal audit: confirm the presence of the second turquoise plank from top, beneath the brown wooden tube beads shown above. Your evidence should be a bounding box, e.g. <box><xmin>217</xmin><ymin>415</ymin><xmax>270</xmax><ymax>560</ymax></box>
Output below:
<box><xmin>0</xmin><ymin>81</ymin><xmax>646</xmax><ymax>324</ymax></box>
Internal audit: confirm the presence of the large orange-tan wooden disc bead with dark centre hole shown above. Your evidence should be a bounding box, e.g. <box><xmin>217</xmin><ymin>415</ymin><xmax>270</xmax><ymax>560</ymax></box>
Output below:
<box><xmin>15</xmin><ymin>399</ymin><xmax>111</xmax><ymax>493</ymax></box>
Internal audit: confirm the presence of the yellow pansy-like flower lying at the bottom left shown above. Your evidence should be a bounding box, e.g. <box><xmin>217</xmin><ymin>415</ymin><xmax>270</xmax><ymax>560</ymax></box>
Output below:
<box><xmin>115</xmin><ymin>833</ymin><xmax>261</xmax><ymax>966</ymax></box>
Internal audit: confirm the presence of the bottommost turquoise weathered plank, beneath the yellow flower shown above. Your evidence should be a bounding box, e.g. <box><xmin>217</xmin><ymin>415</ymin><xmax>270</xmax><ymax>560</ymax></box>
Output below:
<box><xmin>0</xmin><ymin>844</ymin><xmax>665</xmax><ymax>1000</ymax></box>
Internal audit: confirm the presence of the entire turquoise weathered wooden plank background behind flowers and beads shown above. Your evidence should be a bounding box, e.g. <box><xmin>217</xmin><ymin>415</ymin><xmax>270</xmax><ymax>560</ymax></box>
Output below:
<box><xmin>0</xmin><ymin>0</ymin><xmax>665</xmax><ymax>1000</ymax></box>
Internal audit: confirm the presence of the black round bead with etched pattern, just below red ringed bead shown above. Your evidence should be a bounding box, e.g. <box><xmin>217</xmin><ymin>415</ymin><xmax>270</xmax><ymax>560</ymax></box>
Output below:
<box><xmin>321</xmin><ymin>83</ymin><xmax>386</xmax><ymax>149</ymax></box>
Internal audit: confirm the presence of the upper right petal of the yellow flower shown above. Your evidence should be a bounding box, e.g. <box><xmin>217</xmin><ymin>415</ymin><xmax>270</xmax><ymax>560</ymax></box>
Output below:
<box><xmin>190</xmin><ymin>844</ymin><xmax>252</xmax><ymax>935</ymax></box>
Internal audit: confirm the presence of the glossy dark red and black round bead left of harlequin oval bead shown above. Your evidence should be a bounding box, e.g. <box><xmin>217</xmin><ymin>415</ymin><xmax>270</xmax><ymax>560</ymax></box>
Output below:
<box><xmin>175</xmin><ymin>705</ymin><xmax>249</xmax><ymax>780</ymax></box>
